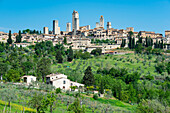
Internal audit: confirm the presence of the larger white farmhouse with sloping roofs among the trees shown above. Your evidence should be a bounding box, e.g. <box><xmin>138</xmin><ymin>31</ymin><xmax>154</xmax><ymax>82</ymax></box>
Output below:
<box><xmin>46</xmin><ymin>73</ymin><xmax>84</xmax><ymax>90</ymax></box>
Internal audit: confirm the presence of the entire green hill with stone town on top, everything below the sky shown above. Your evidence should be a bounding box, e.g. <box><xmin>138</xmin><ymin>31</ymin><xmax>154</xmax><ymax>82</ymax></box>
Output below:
<box><xmin>0</xmin><ymin>10</ymin><xmax>170</xmax><ymax>113</ymax></box>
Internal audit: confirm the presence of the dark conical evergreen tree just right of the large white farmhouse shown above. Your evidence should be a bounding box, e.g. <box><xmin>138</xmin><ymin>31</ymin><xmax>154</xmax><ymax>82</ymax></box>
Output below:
<box><xmin>83</xmin><ymin>66</ymin><xmax>95</xmax><ymax>86</ymax></box>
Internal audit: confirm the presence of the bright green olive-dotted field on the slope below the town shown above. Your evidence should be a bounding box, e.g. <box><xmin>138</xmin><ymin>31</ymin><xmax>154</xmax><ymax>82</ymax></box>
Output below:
<box><xmin>51</xmin><ymin>54</ymin><xmax>160</xmax><ymax>82</ymax></box>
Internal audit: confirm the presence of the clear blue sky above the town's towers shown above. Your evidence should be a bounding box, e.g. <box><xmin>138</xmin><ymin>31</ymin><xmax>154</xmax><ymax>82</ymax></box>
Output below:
<box><xmin>0</xmin><ymin>0</ymin><xmax>170</xmax><ymax>34</ymax></box>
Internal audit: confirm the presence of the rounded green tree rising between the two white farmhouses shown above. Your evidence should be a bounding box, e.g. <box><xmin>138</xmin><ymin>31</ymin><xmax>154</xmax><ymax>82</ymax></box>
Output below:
<box><xmin>37</xmin><ymin>57</ymin><xmax>51</xmax><ymax>82</ymax></box>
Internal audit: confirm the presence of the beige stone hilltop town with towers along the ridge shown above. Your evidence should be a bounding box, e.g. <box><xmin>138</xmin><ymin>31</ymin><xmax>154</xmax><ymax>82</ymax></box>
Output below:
<box><xmin>0</xmin><ymin>10</ymin><xmax>170</xmax><ymax>53</ymax></box>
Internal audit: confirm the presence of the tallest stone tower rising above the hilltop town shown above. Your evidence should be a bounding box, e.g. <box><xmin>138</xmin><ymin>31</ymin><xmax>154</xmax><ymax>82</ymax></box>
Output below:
<box><xmin>72</xmin><ymin>10</ymin><xmax>79</xmax><ymax>31</ymax></box>
